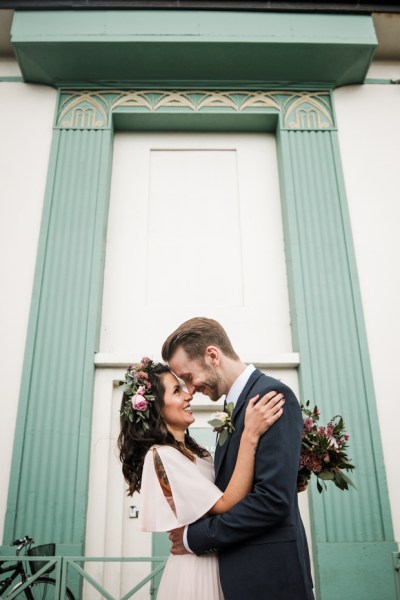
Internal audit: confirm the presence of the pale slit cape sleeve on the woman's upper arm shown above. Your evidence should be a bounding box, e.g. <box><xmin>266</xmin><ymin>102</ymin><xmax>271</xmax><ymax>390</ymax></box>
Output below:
<box><xmin>138</xmin><ymin>446</ymin><xmax>223</xmax><ymax>531</ymax></box>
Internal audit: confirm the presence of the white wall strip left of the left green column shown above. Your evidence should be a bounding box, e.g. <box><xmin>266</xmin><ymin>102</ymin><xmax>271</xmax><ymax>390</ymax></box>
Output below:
<box><xmin>0</xmin><ymin>60</ymin><xmax>56</xmax><ymax>543</ymax></box>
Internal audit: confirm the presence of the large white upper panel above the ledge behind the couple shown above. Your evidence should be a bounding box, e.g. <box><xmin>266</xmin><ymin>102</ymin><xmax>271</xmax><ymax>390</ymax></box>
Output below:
<box><xmin>100</xmin><ymin>133</ymin><xmax>292</xmax><ymax>362</ymax></box>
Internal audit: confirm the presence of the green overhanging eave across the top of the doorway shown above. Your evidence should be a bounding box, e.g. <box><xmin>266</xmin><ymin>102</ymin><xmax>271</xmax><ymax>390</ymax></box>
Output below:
<box><xmin>11</xmin><ymin>10</ymin><xmax>377</xmax><ymax>88</ymax></box>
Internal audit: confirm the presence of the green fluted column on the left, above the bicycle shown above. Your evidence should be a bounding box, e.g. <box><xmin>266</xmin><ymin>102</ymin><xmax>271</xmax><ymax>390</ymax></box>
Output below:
<box><xmin>4</xmin><ymin>128</ymin><xmax>112</xmax><ymax>554</ymax></box>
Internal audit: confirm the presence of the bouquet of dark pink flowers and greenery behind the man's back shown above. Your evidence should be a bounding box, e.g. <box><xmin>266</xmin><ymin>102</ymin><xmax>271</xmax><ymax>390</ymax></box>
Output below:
<box><xmin>298</xmin><ymin>402</ymin><xmax>355</xmax><ymax>493</ymax></box>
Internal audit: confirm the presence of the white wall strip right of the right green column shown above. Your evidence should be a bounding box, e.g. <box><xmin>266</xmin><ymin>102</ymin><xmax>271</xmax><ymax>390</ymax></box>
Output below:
<box><xmin>334</xmin><ymin>63</ymin><xmax>400</xmax><ymax>542</ymax></box>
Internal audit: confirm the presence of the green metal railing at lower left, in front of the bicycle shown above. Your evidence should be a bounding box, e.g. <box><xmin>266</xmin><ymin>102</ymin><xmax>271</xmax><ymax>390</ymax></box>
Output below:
<box><xmin>1</xmin><ymin>555</ymin><xmax>168</xmax><ymax>600</ymax></box>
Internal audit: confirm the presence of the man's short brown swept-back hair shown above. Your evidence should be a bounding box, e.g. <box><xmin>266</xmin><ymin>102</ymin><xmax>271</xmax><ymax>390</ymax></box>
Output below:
<box><xmin>162</xmin><ymin>317</ymin><xmax>239</xmax><ymax>361</ymax></box>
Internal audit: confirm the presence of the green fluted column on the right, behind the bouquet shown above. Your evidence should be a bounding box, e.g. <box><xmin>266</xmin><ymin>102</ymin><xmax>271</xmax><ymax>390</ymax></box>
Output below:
<box><xmin>278</xmin><ymin>106</ymin><xmax>396</xmax><ymax>600</ymax></box>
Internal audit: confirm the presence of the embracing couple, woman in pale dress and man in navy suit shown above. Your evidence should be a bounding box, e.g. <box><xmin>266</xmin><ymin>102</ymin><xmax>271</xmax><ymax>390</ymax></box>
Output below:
<box><xmin>118</xmin><ymin>318</ymin><xmax>314</xmax><ymax>600</ymax></box>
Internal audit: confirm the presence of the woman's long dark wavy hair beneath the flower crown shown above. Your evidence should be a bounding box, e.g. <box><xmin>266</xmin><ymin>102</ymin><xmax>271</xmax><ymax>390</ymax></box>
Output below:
<box><xmin>118</xmin><ymin>363</ymin><xmax>210</xmax><ymax>496</ymax></box>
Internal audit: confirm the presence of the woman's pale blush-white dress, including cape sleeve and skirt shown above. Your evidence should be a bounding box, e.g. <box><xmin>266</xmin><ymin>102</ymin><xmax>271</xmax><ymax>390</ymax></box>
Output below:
<box><xmin>138</xmin><ymin>446</ymin><xmax>224</xmax><ymax>600</ymax></box>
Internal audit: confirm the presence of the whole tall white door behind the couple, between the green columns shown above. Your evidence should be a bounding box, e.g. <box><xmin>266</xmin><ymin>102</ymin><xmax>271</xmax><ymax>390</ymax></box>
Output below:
<box><xmin>86</xmin><ymin>133</ymin><xmax>306</xmax><ymax>598</ymax></box>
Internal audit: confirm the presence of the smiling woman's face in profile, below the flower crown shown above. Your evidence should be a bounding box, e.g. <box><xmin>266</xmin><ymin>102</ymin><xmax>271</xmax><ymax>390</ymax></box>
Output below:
<box><xmin>161</xmin><ymin>373</ymin><xmax>195</xmax><ymax>439</ymax></box>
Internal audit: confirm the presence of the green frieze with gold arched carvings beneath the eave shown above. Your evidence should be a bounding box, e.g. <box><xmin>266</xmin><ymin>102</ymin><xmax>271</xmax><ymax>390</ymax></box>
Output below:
<box><xmin>57</xmin><ymin>90</ymin><xmax>334</xmax><ymax>130</ymax></box>
